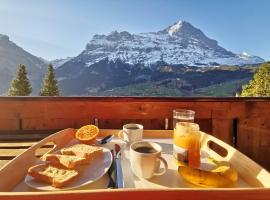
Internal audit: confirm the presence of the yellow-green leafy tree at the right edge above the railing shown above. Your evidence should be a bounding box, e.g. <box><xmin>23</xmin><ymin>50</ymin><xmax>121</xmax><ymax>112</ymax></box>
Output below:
<box><xmin>241</xmin><ymin>62</ymin><xmax>270</xmax><ymax>97</ymax></box>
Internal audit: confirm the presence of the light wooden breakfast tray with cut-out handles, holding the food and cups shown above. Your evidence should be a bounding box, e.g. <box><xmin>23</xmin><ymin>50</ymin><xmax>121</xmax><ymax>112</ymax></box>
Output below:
<box><xmin>0</xmin><ymin>128</ymin><xmax>270</xmax><ymax>200</ymax></box>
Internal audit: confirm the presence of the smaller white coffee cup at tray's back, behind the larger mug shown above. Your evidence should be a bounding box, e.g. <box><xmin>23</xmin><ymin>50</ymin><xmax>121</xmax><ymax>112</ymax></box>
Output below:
<box><xmin>118</xmin><ymin>124</ymin><xmax>143</xmax><ymax>144</ymax></box>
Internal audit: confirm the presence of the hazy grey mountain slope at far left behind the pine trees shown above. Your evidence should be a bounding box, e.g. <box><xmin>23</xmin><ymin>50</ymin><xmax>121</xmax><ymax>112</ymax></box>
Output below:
<box><xmin>0</xmin><ymin>34</ymin><xmax>47</xmax><ymax>95</ymax></box>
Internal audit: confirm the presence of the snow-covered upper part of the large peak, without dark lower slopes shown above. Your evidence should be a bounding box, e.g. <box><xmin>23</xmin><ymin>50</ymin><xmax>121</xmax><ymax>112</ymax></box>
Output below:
<box><xmin>65</xmin><ymin>21</ymin><xmax>264</xmax><ymax>67</ymax></box>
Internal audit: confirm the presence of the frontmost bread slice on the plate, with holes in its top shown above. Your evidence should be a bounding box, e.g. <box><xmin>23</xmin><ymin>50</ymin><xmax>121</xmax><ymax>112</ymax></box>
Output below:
<box><xmin>28</xmin><ymin>164</ymin><xmax>79</xmax><ymax>188</ymax></box>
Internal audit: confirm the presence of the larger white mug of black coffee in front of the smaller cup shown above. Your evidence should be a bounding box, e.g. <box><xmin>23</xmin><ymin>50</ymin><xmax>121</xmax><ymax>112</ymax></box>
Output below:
<box><xmin>130</xmin><ymin>141</ymin><xmax>168</xmax><ymax>179</ymax></box>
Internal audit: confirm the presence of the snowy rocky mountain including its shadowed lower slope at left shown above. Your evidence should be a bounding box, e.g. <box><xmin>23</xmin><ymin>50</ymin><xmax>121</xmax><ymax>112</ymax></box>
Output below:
<box><xmin>56</xmin><ymin>21</ymin><xmax>264</xmax><ymax>95</ymax></box>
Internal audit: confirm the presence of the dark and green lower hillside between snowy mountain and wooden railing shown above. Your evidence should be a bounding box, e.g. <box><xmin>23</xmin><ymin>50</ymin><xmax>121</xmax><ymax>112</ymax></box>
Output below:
<box><xmin>88</xmin><ymin>66</ymin><xmax>257</xmax><ymax>97</ymax></box>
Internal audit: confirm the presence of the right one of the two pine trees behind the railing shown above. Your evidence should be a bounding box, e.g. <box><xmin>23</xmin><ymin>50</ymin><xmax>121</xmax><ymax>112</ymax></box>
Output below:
<box><xmin>39</xmin><ymin>64</ymin><xmax>60</xmax><ymax>96</ymax></box>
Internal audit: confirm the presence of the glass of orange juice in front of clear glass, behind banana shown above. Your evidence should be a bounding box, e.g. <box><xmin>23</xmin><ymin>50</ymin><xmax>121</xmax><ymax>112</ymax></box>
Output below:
<box><xmin>173</xmin><ymin>122</ymin><xmax>201</xmax><ymax>168</ymax></box>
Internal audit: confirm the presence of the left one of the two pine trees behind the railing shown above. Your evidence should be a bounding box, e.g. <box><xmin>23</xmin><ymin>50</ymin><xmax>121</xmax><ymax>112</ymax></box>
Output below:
<box><xmin>8</xmin><ymin>64</ymin><xmax>32</xmax><ymax>96</ymax></box>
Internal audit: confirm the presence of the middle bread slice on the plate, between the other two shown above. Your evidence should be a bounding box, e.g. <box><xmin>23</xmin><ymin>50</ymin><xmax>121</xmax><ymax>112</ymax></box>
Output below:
<box><xmin>43</xmin><ymin>154</ymin><xmax>87</xmax><ymax>169</ymax></box>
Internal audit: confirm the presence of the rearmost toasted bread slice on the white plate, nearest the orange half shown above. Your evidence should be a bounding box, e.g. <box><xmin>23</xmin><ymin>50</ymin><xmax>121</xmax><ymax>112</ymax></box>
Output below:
<box><xmin>61</xmin><ymin>144</ymin><xmax>103</xmax><ymax>160</ymax></box>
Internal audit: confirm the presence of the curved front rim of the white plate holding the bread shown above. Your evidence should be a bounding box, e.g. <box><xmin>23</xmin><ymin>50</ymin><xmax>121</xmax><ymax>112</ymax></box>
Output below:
<box><xmin>24</xmin><ymin>147</ymin><xmax>113</xmax><ymax>191</ymax></box>
